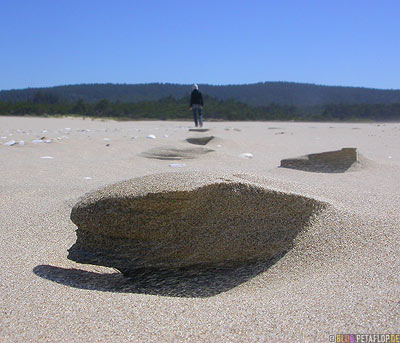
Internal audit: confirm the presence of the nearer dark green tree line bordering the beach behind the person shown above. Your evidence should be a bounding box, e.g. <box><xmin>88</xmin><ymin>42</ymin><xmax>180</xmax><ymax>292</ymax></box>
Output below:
<box><xmin>0</xmin><ymin>91</ymin><xmax>400</xmax><ymax>121</ymax></box>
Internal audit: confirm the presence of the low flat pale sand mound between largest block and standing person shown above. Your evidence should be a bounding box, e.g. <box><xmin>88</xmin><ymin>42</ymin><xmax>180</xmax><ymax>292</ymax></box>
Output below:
<box><xmin>140</xmin><ymin>147</ymin><xmax>214</xmax><ymax>160</ymax></box>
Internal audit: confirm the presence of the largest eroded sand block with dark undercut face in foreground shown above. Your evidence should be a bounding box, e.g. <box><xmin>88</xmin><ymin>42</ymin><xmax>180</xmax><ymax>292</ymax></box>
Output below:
<box><xmin>68</xmin><ymin>172</ymin><xmax>326</xmax><ymax>275</ymax></box>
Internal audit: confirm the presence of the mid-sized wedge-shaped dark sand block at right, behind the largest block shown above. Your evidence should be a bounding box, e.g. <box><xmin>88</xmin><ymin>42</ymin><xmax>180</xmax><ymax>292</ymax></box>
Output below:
<box><xmin>281</xmin><ymin>148</ymin><xmax>358</xmax><ymax>173</ymax></box>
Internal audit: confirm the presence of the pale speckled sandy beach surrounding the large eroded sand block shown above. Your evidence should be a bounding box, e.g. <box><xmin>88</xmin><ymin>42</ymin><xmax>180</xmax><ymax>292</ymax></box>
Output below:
<box><xmin>0</xmin><ymin>117</ymin><xmax>400</xmax><ymax>342</ymax></box>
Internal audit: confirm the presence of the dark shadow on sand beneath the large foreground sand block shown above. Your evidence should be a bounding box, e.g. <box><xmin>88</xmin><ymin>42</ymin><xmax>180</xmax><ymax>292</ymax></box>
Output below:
<box><xmin>33</xmin><ymin>256</ymin><xmax>282</xmax><ymax>298</ymax></box>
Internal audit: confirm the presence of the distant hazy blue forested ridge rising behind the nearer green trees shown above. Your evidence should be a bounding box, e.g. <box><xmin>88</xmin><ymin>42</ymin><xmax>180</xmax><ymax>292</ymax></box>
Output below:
<box><xmin>0</xmin><ymin>82</ymin><xmax>400</xmax><ymax>106</ymax></box>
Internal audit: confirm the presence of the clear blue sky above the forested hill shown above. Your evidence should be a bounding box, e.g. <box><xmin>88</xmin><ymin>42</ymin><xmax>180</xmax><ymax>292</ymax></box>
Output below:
<box><xmin>0</xmin><ymin>0</ymin><xmax>400</xmax><ymax>89</ymax></box>
